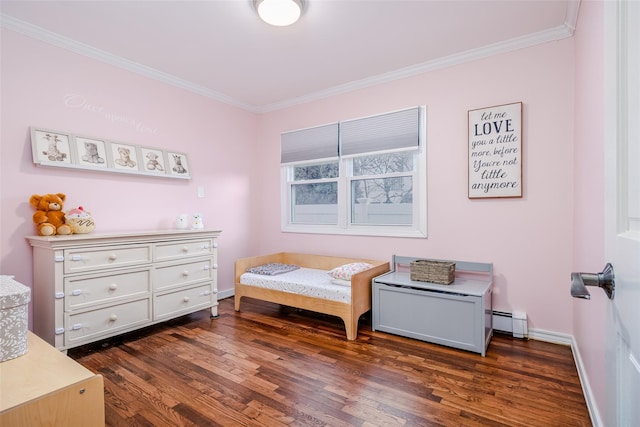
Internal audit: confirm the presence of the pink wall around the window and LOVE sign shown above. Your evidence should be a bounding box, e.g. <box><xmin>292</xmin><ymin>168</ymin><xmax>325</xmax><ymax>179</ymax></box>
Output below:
<box><xmin>252</xmin><ymin>39</ymin><xmax>574</xmax><ymax>334</ymax></box>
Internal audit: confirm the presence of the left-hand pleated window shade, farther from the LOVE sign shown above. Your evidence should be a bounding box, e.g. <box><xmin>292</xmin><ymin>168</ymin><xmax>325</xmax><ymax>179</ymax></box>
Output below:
<box><xmin>280</xmin><ymin>123</ymin><xmax>338</xmax><ymax>163</ymax></box>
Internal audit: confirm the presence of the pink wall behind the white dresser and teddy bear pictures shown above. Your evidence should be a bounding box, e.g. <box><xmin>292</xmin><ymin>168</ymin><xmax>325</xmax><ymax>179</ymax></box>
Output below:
<box><xmin>0</xmin><ymin>30</ymin><xmax>257</xmax><ymax>320</ymax></box>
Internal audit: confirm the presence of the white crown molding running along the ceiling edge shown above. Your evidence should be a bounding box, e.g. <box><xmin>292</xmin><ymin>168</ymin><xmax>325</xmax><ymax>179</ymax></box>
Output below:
<box><xmin>0</xmin><ymin>0</ymin><xmax>581</xmax><ymax>113</ymax></box>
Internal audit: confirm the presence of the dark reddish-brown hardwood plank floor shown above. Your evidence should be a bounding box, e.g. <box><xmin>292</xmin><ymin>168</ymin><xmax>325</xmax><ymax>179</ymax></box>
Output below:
<box><xmin>69</xmin><ymin>298</ymin><xmax>591</xmax><ymax>427</ymax></box>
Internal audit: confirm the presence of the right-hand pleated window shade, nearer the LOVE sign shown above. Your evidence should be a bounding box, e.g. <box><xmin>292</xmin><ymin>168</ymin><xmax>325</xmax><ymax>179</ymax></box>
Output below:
<box><xmin>340</xmin><ymin>107</ymin><xmax>420</xmax><ymax>156</ymax></box>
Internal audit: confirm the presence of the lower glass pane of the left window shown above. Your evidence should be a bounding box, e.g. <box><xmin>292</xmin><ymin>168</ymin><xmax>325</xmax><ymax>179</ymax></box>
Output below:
<box><xmin>291</xmin><ymin>182</ymin><xmax>338</xmax><ymax>224</ymax></box>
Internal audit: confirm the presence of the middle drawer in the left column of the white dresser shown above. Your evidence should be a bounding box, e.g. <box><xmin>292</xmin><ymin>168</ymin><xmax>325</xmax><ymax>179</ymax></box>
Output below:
<box><xmin>64</xmin><ymin>267</ymin><xmax>151</xmax><ymax>311</ymax></box>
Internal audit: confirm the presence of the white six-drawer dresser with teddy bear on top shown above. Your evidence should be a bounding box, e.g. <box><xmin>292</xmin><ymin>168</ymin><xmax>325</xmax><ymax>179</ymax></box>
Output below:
<box><xmin>27</xmin><ymin>230</ymin><xmax>220</xmax><ymax>350</ymax></box>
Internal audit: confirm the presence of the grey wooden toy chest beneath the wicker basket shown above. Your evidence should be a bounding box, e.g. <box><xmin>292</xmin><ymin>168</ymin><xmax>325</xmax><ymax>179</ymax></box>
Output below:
<box><xmin>372</xmin><ymin>256</ymin><xmax>493</xmax><ymax>356</ymax></box>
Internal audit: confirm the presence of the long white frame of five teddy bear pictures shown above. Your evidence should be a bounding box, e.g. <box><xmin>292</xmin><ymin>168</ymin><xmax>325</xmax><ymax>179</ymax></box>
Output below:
<box><xmin>30</xmin><ymin>127</ymin><xmax>191</xmax><ymax>179</ymax></box>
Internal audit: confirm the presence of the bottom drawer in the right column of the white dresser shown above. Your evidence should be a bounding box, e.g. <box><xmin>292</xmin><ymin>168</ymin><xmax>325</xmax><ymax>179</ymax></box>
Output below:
<box><xmin>153</xmin><ymin>283</ymin><xmax>216</xmax><ymax>320</ymax></box>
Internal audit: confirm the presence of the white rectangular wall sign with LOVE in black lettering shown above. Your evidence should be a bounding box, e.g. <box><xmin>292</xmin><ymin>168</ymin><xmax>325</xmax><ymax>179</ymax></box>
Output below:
<box><xmin>469</xmin><ymin>102</ymin><xmax>522</xmax><ymax>199</ymax></box>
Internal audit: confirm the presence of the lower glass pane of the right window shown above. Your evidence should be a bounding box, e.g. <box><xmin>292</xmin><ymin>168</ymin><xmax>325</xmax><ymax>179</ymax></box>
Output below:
<box><xmin>351</xmin><ymin>176</ymin><xmax>413</xmax><ymax>225</ymax></box>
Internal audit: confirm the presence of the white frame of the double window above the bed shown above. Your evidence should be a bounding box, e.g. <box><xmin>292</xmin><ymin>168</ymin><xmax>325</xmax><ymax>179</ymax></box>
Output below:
<box><xmin>280</xmin><ymin>106</ymin><xmax>427</xmax><ymax>238</ymax></box>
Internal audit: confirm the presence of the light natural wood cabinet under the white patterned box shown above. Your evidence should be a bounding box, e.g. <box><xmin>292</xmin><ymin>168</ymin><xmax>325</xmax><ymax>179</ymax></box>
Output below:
<box><xmin>0</xmin><ymin>332</ymin><xmax>104</xmax><ymax>427</ymax></box>
